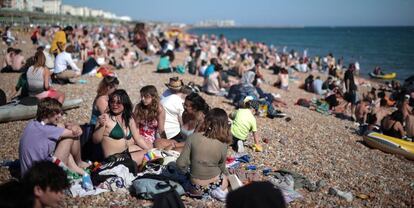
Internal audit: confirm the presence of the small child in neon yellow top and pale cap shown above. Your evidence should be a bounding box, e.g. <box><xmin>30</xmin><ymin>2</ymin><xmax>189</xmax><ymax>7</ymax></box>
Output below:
<box><xmin>230</xmin><ymin>96</ymin><xmax>263</xmax><ymax>152</ymax></box>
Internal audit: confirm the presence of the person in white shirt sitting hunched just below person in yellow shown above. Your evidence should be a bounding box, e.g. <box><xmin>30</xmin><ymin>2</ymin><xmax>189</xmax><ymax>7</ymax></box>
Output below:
<box><xmin>53</xmin><ymin>45</ymin><xmax>82</xmax><ymax>81</ymax></box>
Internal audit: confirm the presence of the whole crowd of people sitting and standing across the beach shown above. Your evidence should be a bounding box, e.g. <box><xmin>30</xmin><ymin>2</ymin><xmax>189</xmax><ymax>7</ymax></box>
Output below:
<box><xmin>2</xmin><ymin>23</ymin><xmax>414</xmax><ymax>207</ymax></box>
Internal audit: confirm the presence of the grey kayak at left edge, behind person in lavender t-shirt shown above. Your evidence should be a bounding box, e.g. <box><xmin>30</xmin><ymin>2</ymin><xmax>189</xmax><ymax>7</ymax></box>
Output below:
<box><xmin>0</xmin><ymin>99</ymin><xmax>83</xmax><ymax>123</ymax></box>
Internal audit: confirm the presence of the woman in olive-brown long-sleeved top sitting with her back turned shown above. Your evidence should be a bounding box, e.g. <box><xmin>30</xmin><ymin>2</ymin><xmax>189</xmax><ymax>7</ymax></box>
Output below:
<box><xmin>177</xmin><ymin>108</ymin><xmax>231</xmax><ymax>201</ymax></box>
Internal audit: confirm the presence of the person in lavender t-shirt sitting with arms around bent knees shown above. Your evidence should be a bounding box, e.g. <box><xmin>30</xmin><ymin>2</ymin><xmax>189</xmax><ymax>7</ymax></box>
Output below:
<box><xmin>19</xmin><ymin>97</ymin><xmax>91</xmax><ymax>189</ymax></box>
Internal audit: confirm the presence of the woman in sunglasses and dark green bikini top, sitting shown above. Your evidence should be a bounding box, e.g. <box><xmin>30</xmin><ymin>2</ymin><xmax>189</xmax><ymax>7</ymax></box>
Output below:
<box><xmin>93</xmin><ymin>89</ymin><xmax>149</xmax><ymax>165</ymax></box>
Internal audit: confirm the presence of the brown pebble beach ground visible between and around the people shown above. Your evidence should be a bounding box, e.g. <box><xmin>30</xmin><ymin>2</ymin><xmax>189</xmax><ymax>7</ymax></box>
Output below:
<box><xmin>0</xmin><ymin>33</ymin><xmax>414</xmax><ymax>207</ymax></box>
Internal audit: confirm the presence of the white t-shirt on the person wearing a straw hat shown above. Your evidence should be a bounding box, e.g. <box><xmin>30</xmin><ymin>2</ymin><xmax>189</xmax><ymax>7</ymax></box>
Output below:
<box><xmin>161</xmin><ymin>94</ymin><xmax>184</xmax><ymax>139</ymax></box>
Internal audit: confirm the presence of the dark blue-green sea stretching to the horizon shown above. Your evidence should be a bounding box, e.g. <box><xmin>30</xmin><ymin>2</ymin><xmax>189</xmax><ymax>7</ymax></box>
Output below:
<box><xmin>189</xmin><ymin>27</ymin><xmax>414</xmax><ymax>80</ymax></box>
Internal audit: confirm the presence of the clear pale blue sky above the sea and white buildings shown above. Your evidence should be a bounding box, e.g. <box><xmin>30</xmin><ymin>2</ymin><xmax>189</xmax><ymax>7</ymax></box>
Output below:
<box><xmin>63</xmin><ymin>0</ymin><xmax>414</xmax><ymax>26</ymax></box>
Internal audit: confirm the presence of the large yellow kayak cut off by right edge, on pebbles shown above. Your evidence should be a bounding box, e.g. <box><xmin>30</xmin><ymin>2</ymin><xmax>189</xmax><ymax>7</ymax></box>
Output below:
<box><xmin>364</xmin><ymin>132</ymin><xmax>414</xmax><ymax>160</ymax></box>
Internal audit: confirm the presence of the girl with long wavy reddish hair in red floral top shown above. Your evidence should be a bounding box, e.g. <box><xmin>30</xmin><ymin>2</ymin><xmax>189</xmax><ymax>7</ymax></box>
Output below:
<box><xmin>134</xmin><ymin>85</ymin><xmax>167</xmax><ymax>147</ymax></box>
